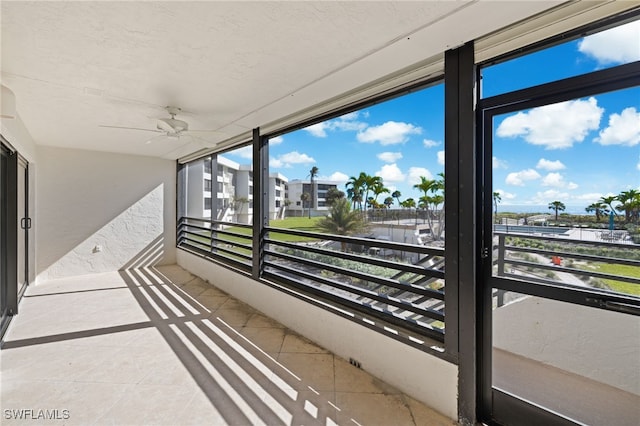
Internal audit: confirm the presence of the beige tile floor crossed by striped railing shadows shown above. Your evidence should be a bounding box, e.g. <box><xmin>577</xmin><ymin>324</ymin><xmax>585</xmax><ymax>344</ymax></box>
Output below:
<box><xmin>0</xmin><ymin>266</ymin><xmax>454</xmax><ymax>426</ymax></box>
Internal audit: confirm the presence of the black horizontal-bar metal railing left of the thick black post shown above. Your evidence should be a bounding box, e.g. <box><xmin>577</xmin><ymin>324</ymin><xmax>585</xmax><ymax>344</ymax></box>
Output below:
<box><xmin>177</xmin><ymin>218</ymin><xmax>445</xmax><ymax>342</ymax></box>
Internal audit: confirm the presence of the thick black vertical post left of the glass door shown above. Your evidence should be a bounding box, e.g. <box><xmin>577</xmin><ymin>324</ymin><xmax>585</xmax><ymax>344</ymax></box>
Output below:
<box><xmin>444</xmin><ymin>43</ymin><xmax>480</xmax><ymax>424</ymax></box>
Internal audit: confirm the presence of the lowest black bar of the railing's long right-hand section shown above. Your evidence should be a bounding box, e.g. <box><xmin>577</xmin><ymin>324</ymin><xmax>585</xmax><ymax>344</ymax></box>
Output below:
<box><xmin>263</xmin><ymin>270</ymin><xmax>444</xmax><ymax>343</ymax></box>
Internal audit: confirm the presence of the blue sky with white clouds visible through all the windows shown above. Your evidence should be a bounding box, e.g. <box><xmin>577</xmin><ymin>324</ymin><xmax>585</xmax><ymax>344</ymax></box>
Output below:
<box><xmin>228</xmin><ymin>21</ymin><xmax>640</xmax><ymax>212</ymax></box>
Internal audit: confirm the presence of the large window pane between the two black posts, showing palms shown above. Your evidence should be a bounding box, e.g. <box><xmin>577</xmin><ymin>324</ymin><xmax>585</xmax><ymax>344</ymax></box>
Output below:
<box><xmin>265</xmin><ymin>84</ymin><xmax>445</xmax><ymax>339</ymax></box>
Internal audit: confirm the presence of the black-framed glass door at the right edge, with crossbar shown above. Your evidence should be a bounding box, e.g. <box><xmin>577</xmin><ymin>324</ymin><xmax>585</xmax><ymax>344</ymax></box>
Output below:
<box><xmin>481</xmin><ymin>62</ymin><xmax>640</xmax><ymax>426</ymax></box>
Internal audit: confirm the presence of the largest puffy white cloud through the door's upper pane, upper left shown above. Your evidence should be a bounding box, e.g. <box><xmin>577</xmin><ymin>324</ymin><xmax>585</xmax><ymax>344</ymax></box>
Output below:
<box><xmin>497</xmin><ymin>97</ymin><xmax>604</xmax><ymax>149</ymax></box>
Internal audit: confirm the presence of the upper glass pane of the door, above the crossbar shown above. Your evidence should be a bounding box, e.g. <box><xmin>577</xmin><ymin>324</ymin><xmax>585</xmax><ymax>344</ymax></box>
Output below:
<box><xmin>493</xmin><ymin>87</ymin><xmax>640</xmax><ymax>296</ymax></box>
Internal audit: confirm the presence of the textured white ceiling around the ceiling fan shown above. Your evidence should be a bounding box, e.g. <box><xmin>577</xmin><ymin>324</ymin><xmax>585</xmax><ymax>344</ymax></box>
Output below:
<box><xmin>0</xmin><ymin>1</ymin><xmax>557</xmax><ymax>158</ymax></box>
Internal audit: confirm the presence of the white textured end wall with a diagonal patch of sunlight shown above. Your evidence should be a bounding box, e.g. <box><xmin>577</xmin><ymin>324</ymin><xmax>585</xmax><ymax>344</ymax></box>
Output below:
<box><xmin>34</xmin><ymin>147</ymin><xmax>176</xmax><ymax>280</ymax></box>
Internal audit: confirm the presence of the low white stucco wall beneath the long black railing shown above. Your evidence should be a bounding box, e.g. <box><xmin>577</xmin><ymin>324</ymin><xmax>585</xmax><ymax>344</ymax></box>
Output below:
<box><xmin>177</xmin><ymin>250</ymin><xmax>458</xmax><ymax>419</ymax></box>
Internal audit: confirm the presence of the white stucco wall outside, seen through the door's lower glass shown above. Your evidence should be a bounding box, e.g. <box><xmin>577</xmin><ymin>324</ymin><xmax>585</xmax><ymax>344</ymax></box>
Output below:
<box><xmin>493</xmin><ymin>296</ymin><xmax>640</xmax><ymax>395</ymax></box>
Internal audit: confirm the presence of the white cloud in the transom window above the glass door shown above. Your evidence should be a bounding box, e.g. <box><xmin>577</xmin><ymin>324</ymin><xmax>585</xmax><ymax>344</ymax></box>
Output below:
<box><xmin>578</xmin><ymin>21</ymin><xmax>640</xmax><ymax>65</ymax></box>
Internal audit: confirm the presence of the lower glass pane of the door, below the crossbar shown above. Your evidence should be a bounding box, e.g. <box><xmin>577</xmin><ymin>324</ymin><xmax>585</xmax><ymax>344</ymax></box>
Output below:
<box><xmin>492</xmin><ymin>289</ymin><xmax>640</xmax><ymax>425</ymax></box>
